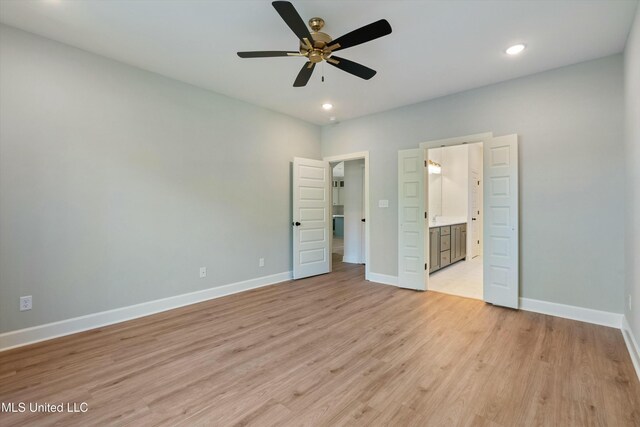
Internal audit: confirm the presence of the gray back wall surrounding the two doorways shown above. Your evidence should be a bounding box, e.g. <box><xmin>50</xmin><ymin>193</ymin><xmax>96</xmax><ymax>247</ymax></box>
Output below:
<box><xmin>322</xmin><ymin>55</ymin><xmax>624</xmax><ymax>313</ymax></box>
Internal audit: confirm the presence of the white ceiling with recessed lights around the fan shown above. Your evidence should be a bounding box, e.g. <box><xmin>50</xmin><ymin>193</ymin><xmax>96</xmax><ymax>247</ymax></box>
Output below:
<box><xmin>0</xmin><ymin>0</ymin><xmax>637</xmax><ymax>124</ymax></box>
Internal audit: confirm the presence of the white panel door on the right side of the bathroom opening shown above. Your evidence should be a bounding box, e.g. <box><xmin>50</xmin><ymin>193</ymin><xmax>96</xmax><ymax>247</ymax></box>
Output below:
<box><xmin>483</xmin><ymin>135</ymin><xmax>519</xmax><ymax>308</ymax></box>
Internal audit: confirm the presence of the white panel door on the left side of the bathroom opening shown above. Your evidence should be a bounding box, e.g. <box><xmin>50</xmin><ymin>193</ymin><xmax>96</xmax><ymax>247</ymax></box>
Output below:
<box><xmin>398</xmin><ymin>148</ymin><xmax>429</xmax><ymax>291</ymax></box>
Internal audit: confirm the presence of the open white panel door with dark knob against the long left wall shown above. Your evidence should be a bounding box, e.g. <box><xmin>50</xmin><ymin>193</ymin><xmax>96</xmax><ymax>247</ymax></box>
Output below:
<box><xmin>292</xmin><ymin>157</ymin><xmax>332</xmax><ymax>279</ymax></box>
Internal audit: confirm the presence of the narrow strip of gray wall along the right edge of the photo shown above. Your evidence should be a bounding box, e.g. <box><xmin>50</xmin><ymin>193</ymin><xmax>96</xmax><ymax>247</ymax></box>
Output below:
<box><xmin>624</xmin><ymin>7</ymin><xmax>640</xmax><ymax>342</ymax></box>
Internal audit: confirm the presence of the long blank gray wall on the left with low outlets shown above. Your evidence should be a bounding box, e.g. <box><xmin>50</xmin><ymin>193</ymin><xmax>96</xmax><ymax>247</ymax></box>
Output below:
<box><xmin>0</xmin><ymin>26</ymin><xmax>320</xmax><ymax>332</ymax></box>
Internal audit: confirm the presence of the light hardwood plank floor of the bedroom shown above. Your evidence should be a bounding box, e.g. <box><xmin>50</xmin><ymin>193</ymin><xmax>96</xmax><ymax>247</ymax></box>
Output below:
<box><xmin>0</xmin><ymin>263</ymin><xmax>640</xmax><ymax>426</ymax></box>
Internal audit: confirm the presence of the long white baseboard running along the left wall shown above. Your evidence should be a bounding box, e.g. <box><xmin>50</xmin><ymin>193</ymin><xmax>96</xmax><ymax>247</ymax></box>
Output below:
<box><xmin>0</xmin><ymin>271</ymin><xmax>292</xmax><ymax>351</ymax></box>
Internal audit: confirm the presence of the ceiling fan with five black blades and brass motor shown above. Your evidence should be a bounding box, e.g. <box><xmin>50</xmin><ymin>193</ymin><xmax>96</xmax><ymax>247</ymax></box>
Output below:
<box><xmin>238</xmin><ymin>1</ymin><xmax>391</xmax><ymax>87</ymax></box>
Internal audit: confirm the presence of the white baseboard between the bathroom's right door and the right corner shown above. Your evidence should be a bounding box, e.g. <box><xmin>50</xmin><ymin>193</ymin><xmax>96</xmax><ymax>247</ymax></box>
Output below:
<box><xmin>520</xmin><ymin>298</ymin><xmax>622</xmax><ymax>329</ymax></box>
